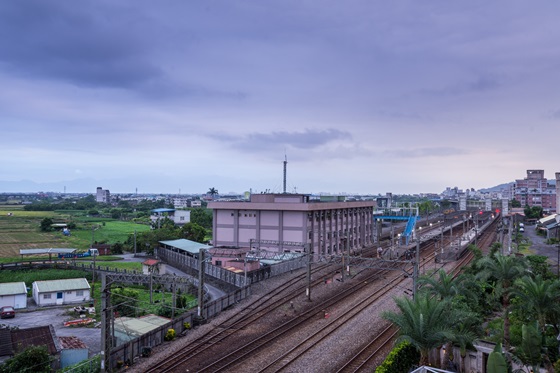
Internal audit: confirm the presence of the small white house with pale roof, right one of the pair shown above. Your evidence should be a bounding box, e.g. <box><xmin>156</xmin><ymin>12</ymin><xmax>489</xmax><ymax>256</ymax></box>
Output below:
<box><xmin>32</xmin><ymin>278</ymin><xmax>91</xmax><ymax>307</ymax></box>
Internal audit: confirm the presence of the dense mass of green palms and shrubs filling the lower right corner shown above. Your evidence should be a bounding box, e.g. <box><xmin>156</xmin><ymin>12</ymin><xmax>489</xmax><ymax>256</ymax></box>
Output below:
<box><xmin>378</xmin><ymin>245</ymin><xmax>560</xmax><ymax>371</ymax></box>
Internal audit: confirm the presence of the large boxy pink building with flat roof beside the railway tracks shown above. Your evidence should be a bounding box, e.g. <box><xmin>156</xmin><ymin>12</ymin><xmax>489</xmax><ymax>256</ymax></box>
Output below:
<box><xmin>208</xmin><ymin>194</ymin><xmax>375</xmax><ymax>255</ymax></box>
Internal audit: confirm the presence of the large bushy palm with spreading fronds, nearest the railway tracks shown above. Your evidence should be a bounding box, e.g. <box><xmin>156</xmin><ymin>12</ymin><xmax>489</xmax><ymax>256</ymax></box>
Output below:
<box><xmin>383</xmin><ymin>294</ymin><xmax>458</xmax><ymax>365</ymax></box>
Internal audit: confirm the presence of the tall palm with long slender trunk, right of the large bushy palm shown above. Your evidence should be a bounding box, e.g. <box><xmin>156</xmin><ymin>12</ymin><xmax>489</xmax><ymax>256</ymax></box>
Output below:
<box><xmin>477</xmin><ymin>253</ymin><xmax>527</xmax><ymax>352</ymax></box>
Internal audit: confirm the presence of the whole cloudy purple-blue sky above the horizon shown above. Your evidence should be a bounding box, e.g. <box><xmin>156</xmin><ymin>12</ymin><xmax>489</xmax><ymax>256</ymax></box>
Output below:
<box><xmin>0</xmin><ymin>0</ymin><xmax>560</xmax><ymax>194</ymax></box>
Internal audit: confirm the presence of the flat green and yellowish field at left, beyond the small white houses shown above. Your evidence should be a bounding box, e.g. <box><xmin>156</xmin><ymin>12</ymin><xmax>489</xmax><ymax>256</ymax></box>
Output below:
<box><xmin>0</xmin><ymin>205</ymin><xmax>150</xmax><ymax>258</ymax></box>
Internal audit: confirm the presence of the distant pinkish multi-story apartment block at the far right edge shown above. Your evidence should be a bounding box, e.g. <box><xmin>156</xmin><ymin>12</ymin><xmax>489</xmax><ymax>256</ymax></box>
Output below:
<box><xmin>514</xmin><ymin>170</ymin><xmax>556</xmax><ymax>212</ymax></box>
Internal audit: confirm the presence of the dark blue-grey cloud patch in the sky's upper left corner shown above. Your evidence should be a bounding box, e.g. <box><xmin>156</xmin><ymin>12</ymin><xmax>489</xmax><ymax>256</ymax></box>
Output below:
<box><xmin>0</xmin><ymin>1</ymin><xmax>163</xmax><ymax>89</ymax></box>
